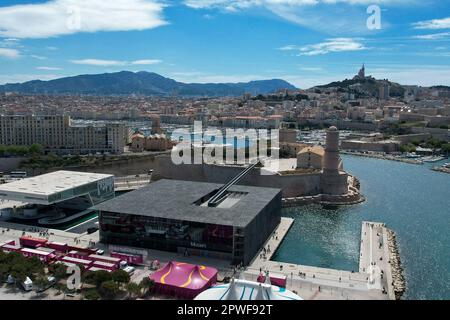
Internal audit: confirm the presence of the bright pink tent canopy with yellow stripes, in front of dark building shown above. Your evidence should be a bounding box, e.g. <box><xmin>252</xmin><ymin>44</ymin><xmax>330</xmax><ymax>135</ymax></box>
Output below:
<box><xmin>150</xmin><ymin>261</ymin><xmax>217</xmax><ymax>299</ymax></box>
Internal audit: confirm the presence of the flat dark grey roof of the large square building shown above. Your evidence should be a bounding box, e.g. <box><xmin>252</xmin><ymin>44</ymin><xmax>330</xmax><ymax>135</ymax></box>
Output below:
<box><xmin>95</xmin><ymin>180</ymin><xmax>281</xmax><ymax>227</ymax></box>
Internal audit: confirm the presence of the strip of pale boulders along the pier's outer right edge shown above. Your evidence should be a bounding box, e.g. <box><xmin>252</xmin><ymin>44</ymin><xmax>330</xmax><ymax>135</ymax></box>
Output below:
<box><xmin>386</xmin><ymin>228</ymin><xmax>406</xmax><ymax>300</ymax></box>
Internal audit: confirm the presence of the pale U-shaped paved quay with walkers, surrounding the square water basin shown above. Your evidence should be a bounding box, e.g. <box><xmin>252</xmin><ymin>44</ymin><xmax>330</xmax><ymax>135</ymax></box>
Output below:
<box><xmin>242</xmin><ymin>218</ymin><xmax>395</xmax><ymax>300</ymax></box>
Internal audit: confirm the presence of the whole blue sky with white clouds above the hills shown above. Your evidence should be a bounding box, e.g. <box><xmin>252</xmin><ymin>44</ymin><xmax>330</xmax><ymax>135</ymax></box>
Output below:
<box><xmin>0</xmin><ymin>0</ymin><xmax>450</xmax><ymax>88</ymax></box>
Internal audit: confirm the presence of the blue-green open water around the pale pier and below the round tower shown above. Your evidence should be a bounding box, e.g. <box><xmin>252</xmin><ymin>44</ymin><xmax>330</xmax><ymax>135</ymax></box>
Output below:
<box><xmin>274</xmin><ymin>156</ymin><xmax>450</xmax><ymax>299</ymax></box>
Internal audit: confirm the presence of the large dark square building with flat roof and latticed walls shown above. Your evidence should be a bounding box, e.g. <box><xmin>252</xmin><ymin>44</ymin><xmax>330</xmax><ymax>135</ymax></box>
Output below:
<box><xmin>95</xmin><ymin>180</ymin><xmax>281</xmax><ymax>264</ymax></box>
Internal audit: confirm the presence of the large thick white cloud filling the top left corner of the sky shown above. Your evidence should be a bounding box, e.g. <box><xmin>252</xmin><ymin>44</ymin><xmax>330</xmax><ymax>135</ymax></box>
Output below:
<box><xmin>0</xmin><ymin>0</ymin><xmax>167</xmax><ymax>38</ymax></box>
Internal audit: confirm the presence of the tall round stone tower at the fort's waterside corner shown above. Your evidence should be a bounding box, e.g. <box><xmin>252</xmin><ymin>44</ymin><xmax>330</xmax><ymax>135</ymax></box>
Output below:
<box><xmin>321</xmin><ymin>127</ymin><xmax>348</xmax><ymax>195</ymax></box>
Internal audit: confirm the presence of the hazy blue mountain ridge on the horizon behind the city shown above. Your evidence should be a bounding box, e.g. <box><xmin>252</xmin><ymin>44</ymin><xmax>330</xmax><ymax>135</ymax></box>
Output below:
<box><xmin>0</xmin><ymin>71</ymin><xmax>296</xmax><ymax>97</ymax></box>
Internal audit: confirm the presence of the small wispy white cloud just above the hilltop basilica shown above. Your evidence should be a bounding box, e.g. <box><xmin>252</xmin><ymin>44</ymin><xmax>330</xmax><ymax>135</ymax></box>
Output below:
<box><xmin>290</xmin><ymin>38</ymin><xmax>367</xmax><ymax>56</ymax></box>
